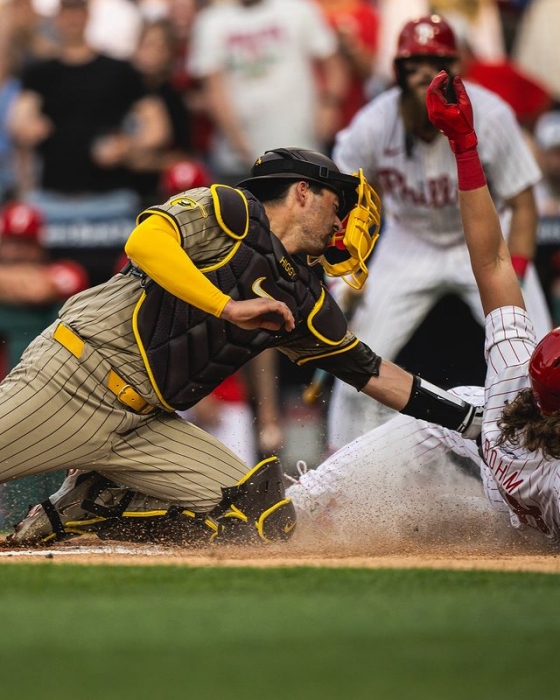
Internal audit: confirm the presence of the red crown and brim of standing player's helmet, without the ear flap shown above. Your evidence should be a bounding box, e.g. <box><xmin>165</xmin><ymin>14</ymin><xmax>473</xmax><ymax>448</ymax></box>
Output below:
<box><xmin>395</xmin><ymin>15</ymin><xmax>458</xmax><ymax>61</ymax></box>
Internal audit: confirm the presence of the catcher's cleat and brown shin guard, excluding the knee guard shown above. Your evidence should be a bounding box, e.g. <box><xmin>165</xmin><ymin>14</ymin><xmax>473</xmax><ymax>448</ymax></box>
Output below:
<box><xmin>8</xmin><ymin>472</ymin><xmax>219</xmax><ymax>545</ymax></box>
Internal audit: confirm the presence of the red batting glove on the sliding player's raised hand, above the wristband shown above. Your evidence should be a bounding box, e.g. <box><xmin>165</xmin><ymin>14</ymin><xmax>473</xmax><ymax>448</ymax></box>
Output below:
<box><xmin>426</xmin><ymin>70</ymin><xmax>478</xmax><ymax>153</ymax></box>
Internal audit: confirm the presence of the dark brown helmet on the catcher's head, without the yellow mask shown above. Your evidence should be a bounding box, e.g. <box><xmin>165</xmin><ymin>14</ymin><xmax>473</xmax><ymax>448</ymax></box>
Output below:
<box><xmin>237</xmin><ymin>148</ymin><xmax>360</xmax><ymax>219</ymax></box>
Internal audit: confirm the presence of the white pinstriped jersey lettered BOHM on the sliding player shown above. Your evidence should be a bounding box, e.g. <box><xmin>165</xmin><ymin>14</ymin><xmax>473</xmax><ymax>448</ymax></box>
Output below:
<box><xmin>482</xmin><ymin>306</ymin><xmax>560</xmax><ymax>538</ymax></box>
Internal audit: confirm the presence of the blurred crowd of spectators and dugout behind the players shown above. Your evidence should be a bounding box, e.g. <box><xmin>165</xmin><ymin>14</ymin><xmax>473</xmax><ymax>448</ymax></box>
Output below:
<box><xmin>0</xmin><ymin>0</ymin><xmax>560</xmax><ymax>524</ymax></box>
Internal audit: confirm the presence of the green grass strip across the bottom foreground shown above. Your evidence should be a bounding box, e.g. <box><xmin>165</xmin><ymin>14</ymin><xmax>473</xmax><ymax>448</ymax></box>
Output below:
<box><xmin>0</xmin><ymin>563</ymin><xmax>560</xmax><ymax>700</ymax></box>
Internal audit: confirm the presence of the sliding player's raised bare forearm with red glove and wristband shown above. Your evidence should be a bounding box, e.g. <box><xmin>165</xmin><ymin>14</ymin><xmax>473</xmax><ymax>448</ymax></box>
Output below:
<box><xmin>426</xmin><ymin>71</ymin><xmax>525</xmax><ymax>314</ymax></box>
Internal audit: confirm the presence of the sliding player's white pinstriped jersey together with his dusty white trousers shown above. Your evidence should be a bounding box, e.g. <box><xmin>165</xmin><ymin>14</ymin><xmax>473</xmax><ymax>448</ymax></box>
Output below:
<box><xmin>286</xmin><ymin>306</ymin><xmax>560</xmax><ymax>541</ymax></box>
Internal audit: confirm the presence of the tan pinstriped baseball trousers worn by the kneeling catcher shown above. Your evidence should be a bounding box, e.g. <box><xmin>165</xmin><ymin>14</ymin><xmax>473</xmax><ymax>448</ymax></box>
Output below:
<box><xmin>0</xmin><ymin>326</ymin><xmax>247</xmax><ymax>511</ymax></box>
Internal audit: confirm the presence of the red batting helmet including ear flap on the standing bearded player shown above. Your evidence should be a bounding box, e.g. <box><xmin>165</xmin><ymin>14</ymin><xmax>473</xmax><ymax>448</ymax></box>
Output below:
<box><xmin>393</xmin><ymin>15</ymin><xmax>459</xmax><ymax>89</ymax></box>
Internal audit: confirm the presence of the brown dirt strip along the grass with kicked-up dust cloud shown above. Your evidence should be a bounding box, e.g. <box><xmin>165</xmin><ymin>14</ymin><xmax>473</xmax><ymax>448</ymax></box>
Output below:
<box><xmin>0</xmin><ymin>454</ymin><xmax>560</xmax><ymax>573</ymax></box>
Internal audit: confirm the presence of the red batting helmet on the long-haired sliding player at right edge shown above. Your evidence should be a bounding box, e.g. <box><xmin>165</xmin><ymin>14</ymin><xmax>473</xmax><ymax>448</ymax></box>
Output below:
<box><xmin>529</xmin><ymin>328</ymin><xmax>560</xmax><ymax>416</ymax></box>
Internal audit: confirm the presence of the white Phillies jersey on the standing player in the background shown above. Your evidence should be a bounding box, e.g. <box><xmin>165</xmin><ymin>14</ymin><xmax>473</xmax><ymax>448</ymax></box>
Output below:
<box><xmin>333</xmin><ymin>82</ymin><xmax>541</xmax><ymax>246</ymax></box>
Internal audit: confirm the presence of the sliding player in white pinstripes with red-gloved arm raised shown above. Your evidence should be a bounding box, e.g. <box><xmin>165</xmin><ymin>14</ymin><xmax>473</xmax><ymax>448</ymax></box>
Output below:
<box><xmin>287</xmin><ymin>71</ymin><xmax>560</xmax><ymax>542</ymax></box>
